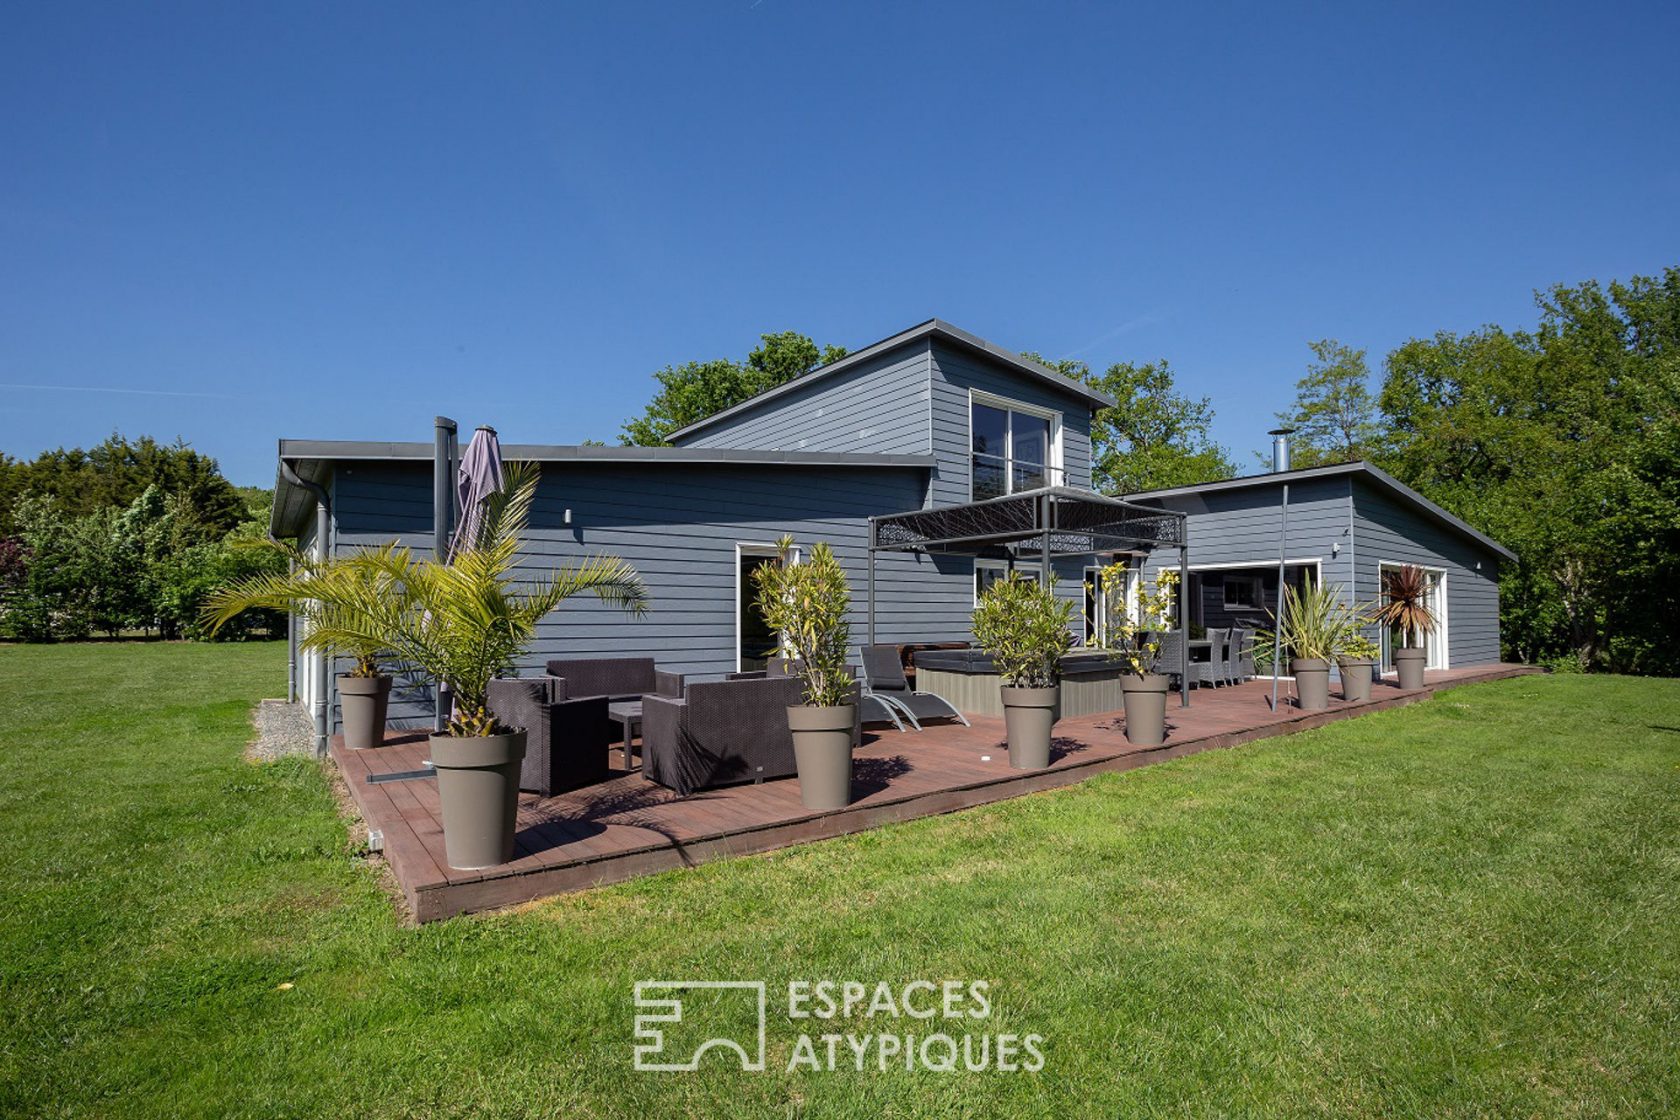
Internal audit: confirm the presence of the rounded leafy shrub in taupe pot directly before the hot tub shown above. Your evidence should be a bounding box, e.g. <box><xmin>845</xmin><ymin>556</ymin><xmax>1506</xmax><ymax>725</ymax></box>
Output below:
<box><xmin>974</xmin><ymin>573</ymin><xmax>1074</xmax><ymax>771</ymax></box>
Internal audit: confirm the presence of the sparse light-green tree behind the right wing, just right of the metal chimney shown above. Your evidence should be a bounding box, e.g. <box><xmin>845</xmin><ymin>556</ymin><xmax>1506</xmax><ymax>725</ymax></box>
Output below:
<box><xmin>1277</xmin><ymin>339</ymin><xmax>1383</xmax><ymax>467</ymax></box>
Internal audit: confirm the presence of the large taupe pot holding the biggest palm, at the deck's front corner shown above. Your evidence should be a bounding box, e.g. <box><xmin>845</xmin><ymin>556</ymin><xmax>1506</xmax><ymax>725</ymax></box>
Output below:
<box><xmin>432</xmin><ymin>730</ymin><xmax>526</xmax><ymax>870</ymax></box>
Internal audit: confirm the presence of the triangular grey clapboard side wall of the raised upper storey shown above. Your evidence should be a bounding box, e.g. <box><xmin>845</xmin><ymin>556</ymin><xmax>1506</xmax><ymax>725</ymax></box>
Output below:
<box><xmin>680</xmin><ymin>341</ymin><xmax>929</xmax><ymax>463</ymax></box>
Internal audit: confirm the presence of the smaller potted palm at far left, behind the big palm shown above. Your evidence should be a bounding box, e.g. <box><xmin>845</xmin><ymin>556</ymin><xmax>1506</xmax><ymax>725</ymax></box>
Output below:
<box><xmin>203</xmin><ymin>542</ymin><xmax>407</xmax><ymax>751</ymax></box>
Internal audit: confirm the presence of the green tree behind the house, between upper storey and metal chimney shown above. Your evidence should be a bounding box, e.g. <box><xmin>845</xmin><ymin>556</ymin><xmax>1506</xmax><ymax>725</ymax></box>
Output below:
<box><xmin>1025</xmin><ymin>353</ymin><xmax>1236</xmax><ymax>495</ymax></box>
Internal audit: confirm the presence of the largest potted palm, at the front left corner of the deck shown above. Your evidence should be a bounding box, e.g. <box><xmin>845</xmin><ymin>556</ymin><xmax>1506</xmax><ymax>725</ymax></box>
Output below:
<box><xmin>374</xmin><ymin>463</ymin><xmax>648</xmax><ymax>868</ymax></box>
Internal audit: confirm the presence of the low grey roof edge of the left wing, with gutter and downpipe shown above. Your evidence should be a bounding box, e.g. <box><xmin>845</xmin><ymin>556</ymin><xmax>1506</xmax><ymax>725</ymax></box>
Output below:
<box><xmin>269</xmin><ymin>440</ymin><xmax>934</xmax><ymax>536</ymax></box>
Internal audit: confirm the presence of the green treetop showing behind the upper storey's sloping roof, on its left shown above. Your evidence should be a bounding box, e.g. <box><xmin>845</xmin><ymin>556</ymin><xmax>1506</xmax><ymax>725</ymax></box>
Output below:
<box><xmin>618</xmin><ymin>331</ymin><xmax>847</xmax><ymax>447</ymax></box>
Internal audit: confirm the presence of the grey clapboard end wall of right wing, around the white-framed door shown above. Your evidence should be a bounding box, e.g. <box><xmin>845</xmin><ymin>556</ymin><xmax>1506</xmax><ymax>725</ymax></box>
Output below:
<box><xmin>1352</xmin><ymin>480</ymin><xmax>1500</xmax><ymax>668</ymax></box>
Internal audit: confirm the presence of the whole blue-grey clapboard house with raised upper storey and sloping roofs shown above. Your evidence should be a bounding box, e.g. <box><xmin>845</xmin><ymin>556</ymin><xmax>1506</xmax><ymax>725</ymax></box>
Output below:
<box><xmin>270</xmin><ymin>319</ymin><xmax>1510</xmax><ymax>725</ymax></box>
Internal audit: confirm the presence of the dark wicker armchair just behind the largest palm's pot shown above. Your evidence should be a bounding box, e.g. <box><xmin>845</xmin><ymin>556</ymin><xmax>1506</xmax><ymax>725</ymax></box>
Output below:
<box><xmin>489</xmin><ymin>677</ymin><xmax>612</xmax><ymax>798</ymax></box>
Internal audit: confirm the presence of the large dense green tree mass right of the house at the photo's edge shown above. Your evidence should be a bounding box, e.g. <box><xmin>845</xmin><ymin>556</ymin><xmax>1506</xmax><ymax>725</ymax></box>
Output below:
<box><xmin>1381</xmin><ymin>269</ymin><xmax>1680</xmax><ymax>673</ymax></box>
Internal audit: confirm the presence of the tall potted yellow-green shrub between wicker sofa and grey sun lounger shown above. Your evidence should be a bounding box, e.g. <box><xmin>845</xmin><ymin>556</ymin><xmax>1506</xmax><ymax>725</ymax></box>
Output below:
<box><xmin>753</xmin><ymin>537</ymin><xmax>857</xmax><ymax>809</ymax></box>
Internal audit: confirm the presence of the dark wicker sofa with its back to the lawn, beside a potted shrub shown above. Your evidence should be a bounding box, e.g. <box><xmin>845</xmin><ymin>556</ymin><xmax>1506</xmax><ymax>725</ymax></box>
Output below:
<box><xmin>642</xmin><ymin>677</ymin><xmax>862</xmax><ymax>794</ymax></box>
